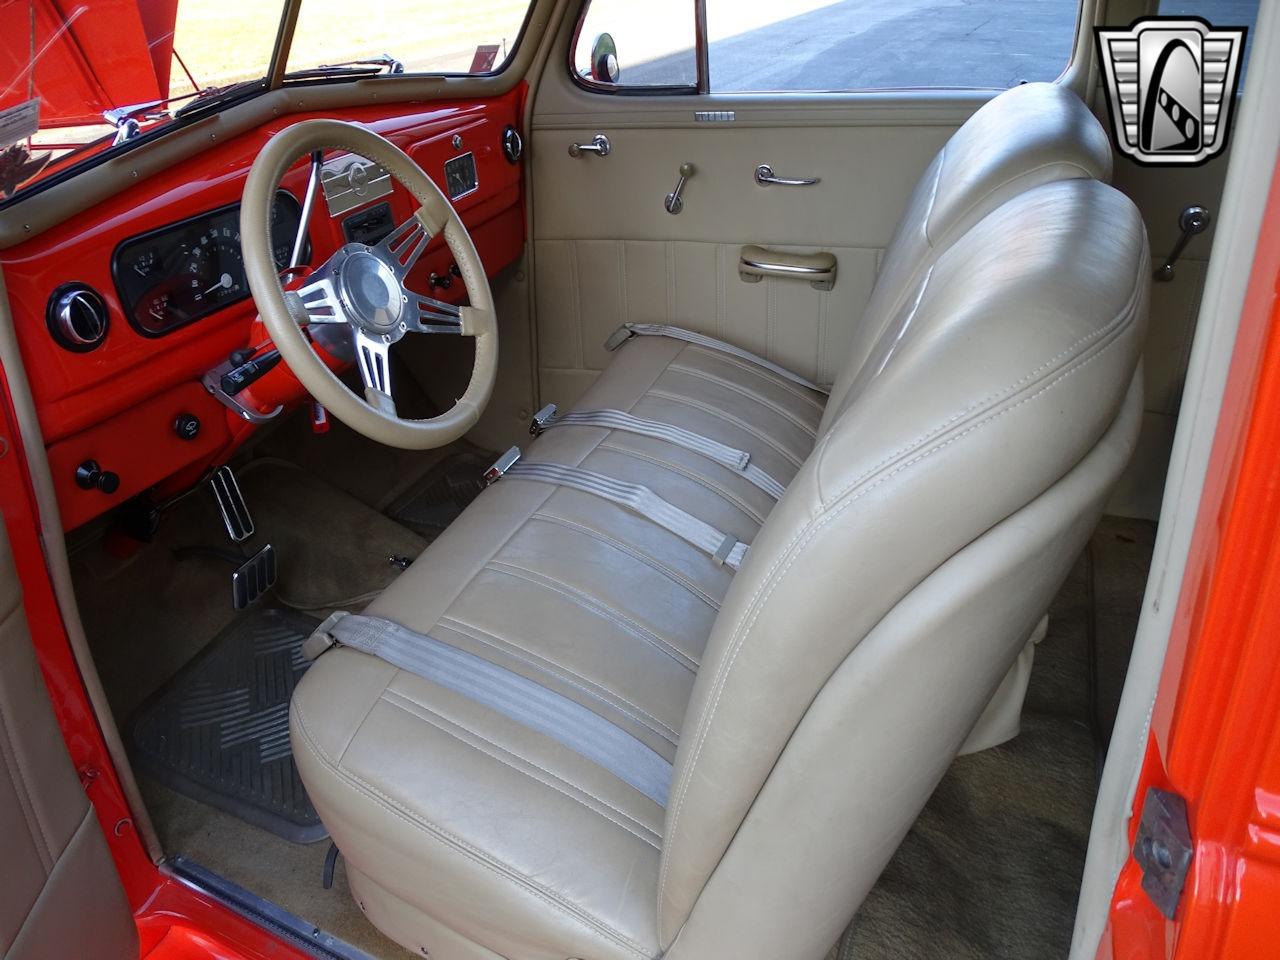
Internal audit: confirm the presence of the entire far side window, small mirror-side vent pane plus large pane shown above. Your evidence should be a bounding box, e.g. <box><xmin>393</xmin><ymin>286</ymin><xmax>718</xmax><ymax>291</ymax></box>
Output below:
<box><xmin>573</xmin><ymin>0</ymin><xmax>1085</xmax><ymax>93</ymax></box>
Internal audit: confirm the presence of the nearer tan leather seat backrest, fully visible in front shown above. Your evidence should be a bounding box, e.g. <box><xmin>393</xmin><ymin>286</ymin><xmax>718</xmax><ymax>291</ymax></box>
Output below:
<box><xmin>658</xmin><ymin>178</ymin><xmax>1149</xmax><ymax>960</ymax></box>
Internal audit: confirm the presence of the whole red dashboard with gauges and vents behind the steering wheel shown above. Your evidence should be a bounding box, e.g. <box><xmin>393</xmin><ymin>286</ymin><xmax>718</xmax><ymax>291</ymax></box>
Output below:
<box><xmin>0</xmin><ymin>87</ymin><xmax>525</xmax><ymax>530</ymax></box>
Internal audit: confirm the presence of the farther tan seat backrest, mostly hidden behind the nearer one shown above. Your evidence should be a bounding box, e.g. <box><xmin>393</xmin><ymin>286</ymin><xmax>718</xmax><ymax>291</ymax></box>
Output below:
<box><xmin>819</xmin><ymin>83</ymin><xmax>1111</xmax><ymax>433</ymax></box>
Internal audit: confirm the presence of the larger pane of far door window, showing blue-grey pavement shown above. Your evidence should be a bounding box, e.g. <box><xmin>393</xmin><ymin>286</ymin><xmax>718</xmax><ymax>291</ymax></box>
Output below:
<box><xmin>707</xmin><ymin>0</ymin><xmax>1079</xmax><ymax>93</ymax></box>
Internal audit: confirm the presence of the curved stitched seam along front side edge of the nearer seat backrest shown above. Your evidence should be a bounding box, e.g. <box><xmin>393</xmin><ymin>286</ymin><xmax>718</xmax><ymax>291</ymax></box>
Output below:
<box><xmin>658</xmin><ymin>325</ymin><xmax>1120</xmax><ymax>931</ymax></box>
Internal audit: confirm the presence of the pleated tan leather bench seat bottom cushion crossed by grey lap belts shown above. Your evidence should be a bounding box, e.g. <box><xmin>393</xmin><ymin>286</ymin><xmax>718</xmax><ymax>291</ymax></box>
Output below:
<box><xmin>293</xmin><ymin>338</ymin><xmax>824</xmax><ymax>960</ymax></box>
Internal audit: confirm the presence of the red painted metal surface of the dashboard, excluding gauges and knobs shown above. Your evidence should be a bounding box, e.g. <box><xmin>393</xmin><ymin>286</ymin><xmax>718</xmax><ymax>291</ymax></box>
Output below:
<box><xmin>0</xmin><ymin>88</ymin><xmax>524</xmax><ymax>529</ymax></box>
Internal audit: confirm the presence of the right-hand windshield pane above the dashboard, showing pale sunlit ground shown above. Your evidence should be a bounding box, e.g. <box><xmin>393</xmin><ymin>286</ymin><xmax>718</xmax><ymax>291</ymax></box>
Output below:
<box><xmin>287</xmin><ymin>0</ymin><xmax>530</xmax><ymax>73</ymax></box>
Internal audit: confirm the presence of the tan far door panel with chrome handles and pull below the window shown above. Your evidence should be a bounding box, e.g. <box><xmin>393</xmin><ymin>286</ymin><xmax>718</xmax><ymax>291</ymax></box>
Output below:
<box><xmin>530</xmin><ymin>58</ymin><xmax>972</xmax><ymax>406</ymax></box>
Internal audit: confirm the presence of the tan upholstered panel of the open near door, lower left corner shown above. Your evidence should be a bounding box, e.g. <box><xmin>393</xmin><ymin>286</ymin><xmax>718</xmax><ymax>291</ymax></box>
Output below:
<box><xmin>0</xmin><ymin>527</ymin><xmax>138</xmax><ymax>960</ymax></box>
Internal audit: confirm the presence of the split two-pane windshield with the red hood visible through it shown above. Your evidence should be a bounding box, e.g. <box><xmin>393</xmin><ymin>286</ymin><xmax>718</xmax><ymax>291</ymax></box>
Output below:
<box><xmin>0</xmin><ymin>0</ymin><xmax>529</xmax><ymax>202</ymax></box>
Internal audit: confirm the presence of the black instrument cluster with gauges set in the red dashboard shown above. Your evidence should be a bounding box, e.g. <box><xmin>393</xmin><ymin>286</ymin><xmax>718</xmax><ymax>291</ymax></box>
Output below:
<box><xmin>111</xmin><ymin>191</ymin><xmax>310</xmax><ymax>337</ymax></box>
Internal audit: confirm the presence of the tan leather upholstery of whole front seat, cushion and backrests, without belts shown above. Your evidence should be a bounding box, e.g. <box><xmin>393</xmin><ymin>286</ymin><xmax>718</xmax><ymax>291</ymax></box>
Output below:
<box><xmin>292</xmin><ymin>84</ymin><xmax>1148</xmax><ymax>960</ymax></box>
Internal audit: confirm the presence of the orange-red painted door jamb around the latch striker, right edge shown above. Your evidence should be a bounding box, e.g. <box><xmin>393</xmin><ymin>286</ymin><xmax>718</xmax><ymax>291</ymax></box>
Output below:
<box><xmin>1098</xmin><ymin>160</ymin><xmax>1280</xmax><ymax>960</ymax></box>
